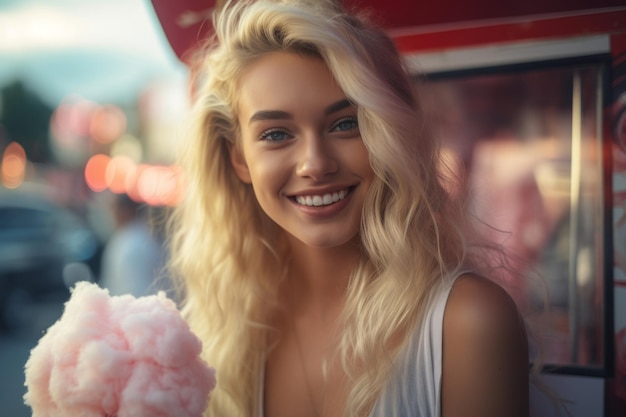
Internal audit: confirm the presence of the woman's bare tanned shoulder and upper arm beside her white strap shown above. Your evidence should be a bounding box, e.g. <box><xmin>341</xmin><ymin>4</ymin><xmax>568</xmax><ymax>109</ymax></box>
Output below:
<box><xmin>442</xmin><ymin>274</ymin><xmax>529</xmax><ymax>417</ymax></box>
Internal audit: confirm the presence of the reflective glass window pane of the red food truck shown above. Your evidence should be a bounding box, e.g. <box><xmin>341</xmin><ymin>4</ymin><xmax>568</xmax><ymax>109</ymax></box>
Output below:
<box><xmin>420</xmin><ymin>65</ymin><xmax>604</xmax><ymax>367</ymax></box>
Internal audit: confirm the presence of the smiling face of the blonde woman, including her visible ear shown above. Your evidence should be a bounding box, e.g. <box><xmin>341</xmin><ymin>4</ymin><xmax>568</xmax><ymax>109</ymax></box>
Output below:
<box><xmin>231</xmin><ymin>52</ymin><xmax>374</xmax><ymax>247</ymax></box>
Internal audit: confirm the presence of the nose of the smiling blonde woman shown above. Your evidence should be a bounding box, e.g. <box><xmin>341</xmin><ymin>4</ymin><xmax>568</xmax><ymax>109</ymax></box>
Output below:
<box><xmin>296</xmin><ymin>133</ymin><xmax>339</xmax><ymax>181</ymax></box>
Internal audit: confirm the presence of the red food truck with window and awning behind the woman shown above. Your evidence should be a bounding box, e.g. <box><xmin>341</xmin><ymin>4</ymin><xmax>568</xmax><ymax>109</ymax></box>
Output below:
<box><xmin>152</xmin><ymin>0</ymin><xmax>626</xmax><ymax>417</ymax></box>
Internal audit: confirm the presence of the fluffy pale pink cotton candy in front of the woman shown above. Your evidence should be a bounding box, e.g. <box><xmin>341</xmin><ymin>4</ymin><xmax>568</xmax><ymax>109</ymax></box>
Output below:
<box><xmin>24</xmin><ymin>282</ymin><xmax>215</xmax><ymax>417</ymax></box>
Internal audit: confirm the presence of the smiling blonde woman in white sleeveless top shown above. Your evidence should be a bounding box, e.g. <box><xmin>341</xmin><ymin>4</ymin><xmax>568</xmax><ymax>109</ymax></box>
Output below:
<box><xmin>171</xmin><ymin>0</ymin><xmax>528</xmax><ymax>417</ymax></box>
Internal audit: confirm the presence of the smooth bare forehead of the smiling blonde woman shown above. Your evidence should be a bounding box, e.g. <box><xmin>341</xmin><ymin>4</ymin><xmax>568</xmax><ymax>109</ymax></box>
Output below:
<box><xmin>238</xmin><ymin>52</ymin><xmax>345</xmax><ymax>121</ymax></box>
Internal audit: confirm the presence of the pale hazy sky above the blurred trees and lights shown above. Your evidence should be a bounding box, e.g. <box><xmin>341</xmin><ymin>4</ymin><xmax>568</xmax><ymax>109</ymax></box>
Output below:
<box><xmin>0</xmin><ymin>0</ymin><xmax>186</xmax><ymax>106</ymax></box>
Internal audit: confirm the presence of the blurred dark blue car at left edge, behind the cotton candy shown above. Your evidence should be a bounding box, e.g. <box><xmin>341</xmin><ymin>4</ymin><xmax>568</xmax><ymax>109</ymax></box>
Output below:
<box><xmin>0</xmin><ymin>189</ymin><xmax>99</xmax><ymax>330</ymax></box>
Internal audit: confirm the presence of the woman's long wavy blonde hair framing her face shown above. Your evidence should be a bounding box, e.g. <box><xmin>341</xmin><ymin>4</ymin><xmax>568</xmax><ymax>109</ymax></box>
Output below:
<box><xmin>170</xmin><ymin>0</ymin><xmax>476</xmax><ymax>417</ymax></box>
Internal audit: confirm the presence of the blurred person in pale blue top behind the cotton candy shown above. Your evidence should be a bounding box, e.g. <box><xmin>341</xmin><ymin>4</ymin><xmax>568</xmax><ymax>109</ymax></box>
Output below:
<box><xmin>99</xmin><ymin>194</ymin><xmax>169</xmax><ymax>297</ymax></box>
